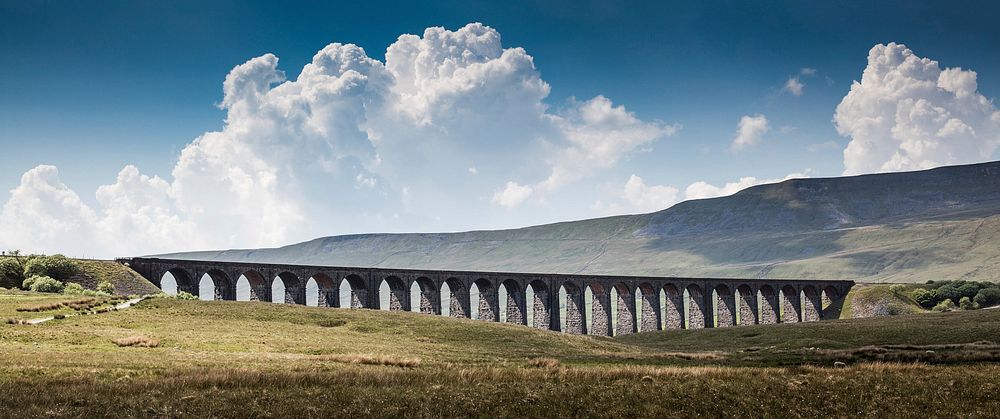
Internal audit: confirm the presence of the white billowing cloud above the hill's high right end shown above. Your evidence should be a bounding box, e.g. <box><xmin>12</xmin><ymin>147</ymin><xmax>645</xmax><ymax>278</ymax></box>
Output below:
<box><xmin>834</xmin><ymin>43</ymin><xmax>1000</xmax><ymax>175</ymax></box>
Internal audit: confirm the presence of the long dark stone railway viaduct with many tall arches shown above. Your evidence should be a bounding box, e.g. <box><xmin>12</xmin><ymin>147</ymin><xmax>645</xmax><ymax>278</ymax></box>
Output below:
<box><xmin>119</xmin><ymin>258</ymin><xmax>854</xmax><ymax>336</ymax></box>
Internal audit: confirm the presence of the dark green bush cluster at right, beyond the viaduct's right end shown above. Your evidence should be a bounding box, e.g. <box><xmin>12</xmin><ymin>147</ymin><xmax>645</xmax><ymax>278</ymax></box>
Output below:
<box><xmin>910</xmin><ymin>281</ymin><xmax>1000</xmax><ymax>311</ymax></box>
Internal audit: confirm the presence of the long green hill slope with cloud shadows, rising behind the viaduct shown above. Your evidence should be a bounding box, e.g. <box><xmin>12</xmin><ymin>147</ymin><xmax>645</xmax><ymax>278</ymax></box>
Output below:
<box><xmin>156</xmin><ymin>162</ymin><xmax>1000</xmax><ymax>282</ymax></box>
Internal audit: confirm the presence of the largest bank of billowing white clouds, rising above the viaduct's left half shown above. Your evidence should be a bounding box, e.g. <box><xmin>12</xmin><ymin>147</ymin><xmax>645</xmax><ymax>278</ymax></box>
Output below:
<box><xmin>0</xmin><ymin>23</ymin><xmax>676</xmax><ymax>256</ymax></box>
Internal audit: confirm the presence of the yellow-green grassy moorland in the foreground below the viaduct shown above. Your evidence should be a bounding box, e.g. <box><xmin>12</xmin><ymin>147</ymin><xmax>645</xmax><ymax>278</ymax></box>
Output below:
<box><xmin>0</xmin><ymin>298</ymin><xmax>1000</xmax><ymax>417</ymax></box>
